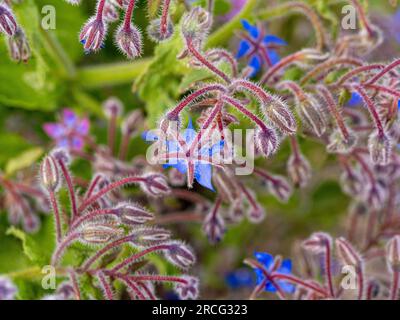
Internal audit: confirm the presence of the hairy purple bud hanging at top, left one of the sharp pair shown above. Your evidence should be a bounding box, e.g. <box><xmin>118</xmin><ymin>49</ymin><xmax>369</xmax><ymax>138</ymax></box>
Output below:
<box><xmin>79</xmin><ymin>16</ymin><xmax>107</xmax><ymax>52</ymax></box>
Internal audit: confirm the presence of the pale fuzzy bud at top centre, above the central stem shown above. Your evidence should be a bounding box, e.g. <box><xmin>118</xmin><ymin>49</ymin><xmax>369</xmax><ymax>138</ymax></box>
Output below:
<box><xmin>182</xmin><ymin>7</ymin><xmax>212</xmax><ymax>42</ymax></box>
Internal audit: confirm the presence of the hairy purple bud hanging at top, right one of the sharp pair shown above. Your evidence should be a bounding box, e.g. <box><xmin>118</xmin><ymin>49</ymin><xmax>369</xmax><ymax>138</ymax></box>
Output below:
<box><xmin>115</xmin><ymin>23</ymin><xmax>142</xmax><ymax>59</ymax></box>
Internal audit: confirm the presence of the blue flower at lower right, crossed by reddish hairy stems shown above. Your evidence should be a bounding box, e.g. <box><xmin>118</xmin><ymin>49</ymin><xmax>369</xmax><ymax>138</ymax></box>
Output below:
<box><xmin>254</xmin><ymin>252</ymin><xmax>294</xmax><ymax>293</ymax></box>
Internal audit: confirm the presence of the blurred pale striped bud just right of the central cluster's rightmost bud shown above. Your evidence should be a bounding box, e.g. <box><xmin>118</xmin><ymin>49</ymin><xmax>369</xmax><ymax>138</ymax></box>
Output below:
<box><xmin>297</xmin><ymin>95</ymin><xmax>327</xmax><ymax>137</ymax></box>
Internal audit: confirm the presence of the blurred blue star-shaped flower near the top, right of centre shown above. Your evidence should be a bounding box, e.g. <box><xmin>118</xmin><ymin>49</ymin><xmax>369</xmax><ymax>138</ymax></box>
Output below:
<box><xmin>236</xmin><ymin>20</ymin><xmax>287</xmax><ymax>77</ymax></box>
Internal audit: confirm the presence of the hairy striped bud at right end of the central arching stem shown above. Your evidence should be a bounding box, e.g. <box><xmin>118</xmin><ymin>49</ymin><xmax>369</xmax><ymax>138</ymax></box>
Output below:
<box><xmin>263</xmin><ymin>97</ymin><xmax>297</xmax><ymax>134</ymax></box>
